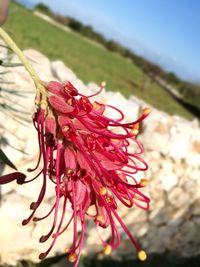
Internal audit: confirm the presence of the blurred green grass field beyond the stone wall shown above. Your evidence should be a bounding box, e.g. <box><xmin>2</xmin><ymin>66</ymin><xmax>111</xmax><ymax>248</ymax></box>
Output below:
<box><xmin>4</xmin><ymin>3</ymin><xmax>193</xmax><ymax>119</ymax></box>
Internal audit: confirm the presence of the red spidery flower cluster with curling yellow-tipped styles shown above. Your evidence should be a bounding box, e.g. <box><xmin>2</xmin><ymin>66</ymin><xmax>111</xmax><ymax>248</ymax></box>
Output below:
<box><xmin>0</xmin><ymin>81</ymin><xmax>149</xmax><ymax>267</ymax></box>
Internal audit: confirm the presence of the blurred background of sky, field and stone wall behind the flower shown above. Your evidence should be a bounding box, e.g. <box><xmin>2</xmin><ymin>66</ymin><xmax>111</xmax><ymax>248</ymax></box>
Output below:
<box><xmin>0</xmin><ymin>0</ymin><xmax>200</xmax><ymax>267</ymax></box>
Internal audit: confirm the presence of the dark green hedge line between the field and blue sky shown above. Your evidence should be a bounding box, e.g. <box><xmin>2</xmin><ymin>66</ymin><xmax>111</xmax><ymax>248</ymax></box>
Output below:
<box><xmin>35</xmin><ymin>3</ymin><xmax>200</xmax><ymax>113</ymax></box>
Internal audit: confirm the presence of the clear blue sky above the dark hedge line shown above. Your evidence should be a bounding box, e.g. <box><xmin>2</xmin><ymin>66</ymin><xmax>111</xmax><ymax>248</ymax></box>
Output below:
<box><xmin>19</xmin><ymin>0</ymin><xmax>200</xmax><ymax>81</ymax></box>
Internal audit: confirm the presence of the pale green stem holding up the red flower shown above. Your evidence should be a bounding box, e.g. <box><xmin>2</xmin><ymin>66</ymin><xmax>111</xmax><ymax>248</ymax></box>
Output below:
<box><xmin>0</xmin><ymin>27</ymin><xmax>46</xmax><ymax>103</ymax></box>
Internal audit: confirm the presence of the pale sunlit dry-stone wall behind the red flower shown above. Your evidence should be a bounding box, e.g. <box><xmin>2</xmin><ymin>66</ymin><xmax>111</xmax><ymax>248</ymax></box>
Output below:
<box><xmin>0</xmin><ymin>49</ymin><xmax>200</xmax><ymax>264</ymax></box>
